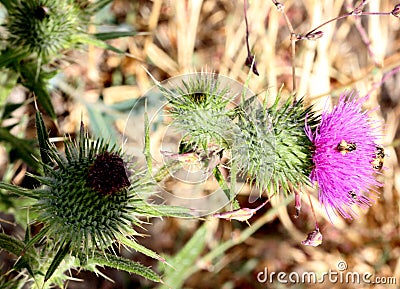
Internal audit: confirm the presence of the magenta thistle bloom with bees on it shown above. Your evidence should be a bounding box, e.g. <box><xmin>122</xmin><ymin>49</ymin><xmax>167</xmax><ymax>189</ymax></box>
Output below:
<box><xmin>305</xmin><ymin>92</ymin><xmax>384</xmax><ymax>220</ymax></box>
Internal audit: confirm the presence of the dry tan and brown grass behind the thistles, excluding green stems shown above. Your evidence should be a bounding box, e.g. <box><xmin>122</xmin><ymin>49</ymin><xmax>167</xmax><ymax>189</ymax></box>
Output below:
<box><xmin>4</xmin><ymin>0</ymin><xmax>400</xmax><ymax>289</ymax></box>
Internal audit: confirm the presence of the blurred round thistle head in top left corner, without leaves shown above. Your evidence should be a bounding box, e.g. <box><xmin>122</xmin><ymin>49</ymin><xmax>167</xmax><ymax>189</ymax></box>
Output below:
<box><xmin>6</xmin><ymin>0</ymin><xmax>88</xmax><ymax>62</ymax></box>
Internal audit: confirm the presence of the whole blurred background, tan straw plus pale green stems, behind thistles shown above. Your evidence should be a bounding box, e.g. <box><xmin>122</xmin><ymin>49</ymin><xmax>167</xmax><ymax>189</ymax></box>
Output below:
<box><xmin>0</xmin><ymin>0</ymin><xmax>400</xmax><ymax>289</ymax></box>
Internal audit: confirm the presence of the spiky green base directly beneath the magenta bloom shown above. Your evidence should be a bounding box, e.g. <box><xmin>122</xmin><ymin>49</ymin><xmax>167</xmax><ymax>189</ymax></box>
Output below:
<box><xmin>232</xmin><ymin>94</ymin><xmax>316</xmax><ymax>194</ymax></box>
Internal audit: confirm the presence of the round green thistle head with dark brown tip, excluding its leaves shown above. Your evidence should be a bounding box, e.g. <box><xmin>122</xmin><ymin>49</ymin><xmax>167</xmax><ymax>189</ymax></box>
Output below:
<box><xmin>34</xmin><ymin>125</ymin><xmax>150</xmax><ymax>256</ymax></box>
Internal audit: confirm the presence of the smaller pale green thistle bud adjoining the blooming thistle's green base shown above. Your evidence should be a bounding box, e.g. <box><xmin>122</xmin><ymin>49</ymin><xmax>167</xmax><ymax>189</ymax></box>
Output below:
<box><xmin>159</xmin><ymin>73</ymin><xmax>238</xmax><ymax>150</ymax></box>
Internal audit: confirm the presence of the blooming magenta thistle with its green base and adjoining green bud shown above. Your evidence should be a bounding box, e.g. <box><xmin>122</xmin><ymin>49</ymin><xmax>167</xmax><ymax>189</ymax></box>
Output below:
<box><xmin>152</xmin><ymin>67</ymin><xmax>384</xmax><ymax>246</ymax></box>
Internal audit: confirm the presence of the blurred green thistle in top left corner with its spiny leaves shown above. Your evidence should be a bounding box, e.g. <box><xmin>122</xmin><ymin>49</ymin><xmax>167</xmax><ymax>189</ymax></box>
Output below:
<box><xmin>0</xmin><ymin>0</ymin><xmax>138</xmax><ymax>119</ymax></box>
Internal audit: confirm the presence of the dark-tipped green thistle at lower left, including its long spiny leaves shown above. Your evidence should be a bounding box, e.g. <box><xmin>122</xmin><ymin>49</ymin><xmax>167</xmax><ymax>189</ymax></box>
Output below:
<box><xmin>0</xmin><ymin>113</ymin><xmax>190</xmax><ymax>286</ymax></box>
